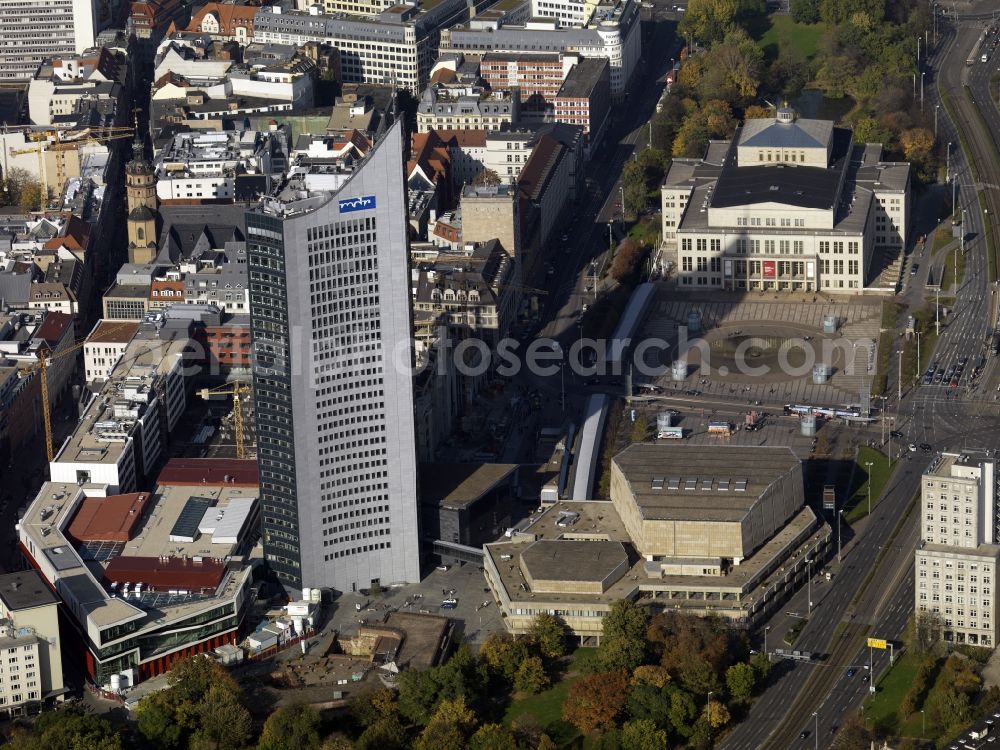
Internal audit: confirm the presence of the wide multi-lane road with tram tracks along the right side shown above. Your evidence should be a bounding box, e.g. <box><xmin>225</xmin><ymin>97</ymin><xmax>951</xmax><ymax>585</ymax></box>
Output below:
<box><xmin>722</xmin><ymin>8</ymin><xmax>1000</xmax><ymax>750</ymax></box>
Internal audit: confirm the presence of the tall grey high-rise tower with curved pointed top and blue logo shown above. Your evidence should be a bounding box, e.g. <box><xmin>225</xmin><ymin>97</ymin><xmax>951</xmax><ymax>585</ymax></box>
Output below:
<box><xmin>247</xmin><ymin>122</ymin><xmax>419</xmax><ymax>591</ymax></box>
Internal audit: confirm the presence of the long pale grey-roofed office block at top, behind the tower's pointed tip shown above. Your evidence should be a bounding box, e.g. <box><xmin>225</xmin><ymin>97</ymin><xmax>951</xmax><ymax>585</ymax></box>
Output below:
<box><xmin>253</xmin><ymin>0</ymin><xmax>480</xmax><ymax>96</ymax></box>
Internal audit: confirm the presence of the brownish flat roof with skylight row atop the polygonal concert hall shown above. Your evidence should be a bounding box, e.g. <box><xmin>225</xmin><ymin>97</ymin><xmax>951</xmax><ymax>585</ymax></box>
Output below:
<box><xmin>613</xmin><ymin>443</ymin><xmax>802</xmax><ymax>522</ymax></box>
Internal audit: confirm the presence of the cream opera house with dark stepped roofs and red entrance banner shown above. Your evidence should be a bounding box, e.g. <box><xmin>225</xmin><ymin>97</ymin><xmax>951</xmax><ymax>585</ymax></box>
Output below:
<box><xmin>661</xmin><ymin>109</ymin><xmax>910</xmax><ymax>293</ymax></box>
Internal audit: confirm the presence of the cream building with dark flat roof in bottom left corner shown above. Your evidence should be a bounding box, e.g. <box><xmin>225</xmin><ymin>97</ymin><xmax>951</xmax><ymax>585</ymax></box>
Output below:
<box><xmin>0</xmin><ymin>570</ymin><xmax>66</xmax><ymax>715</ymax></box>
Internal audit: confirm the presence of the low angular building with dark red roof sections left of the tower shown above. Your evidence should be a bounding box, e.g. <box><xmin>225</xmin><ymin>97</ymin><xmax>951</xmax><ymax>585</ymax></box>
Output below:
<box><xmin>18</xmin><ymin>459</ymin><xmax>260</xmax><ymax>692</ymax></box>
